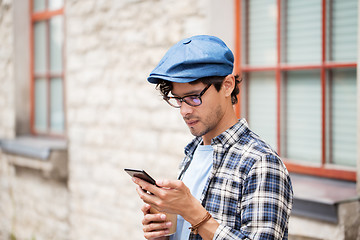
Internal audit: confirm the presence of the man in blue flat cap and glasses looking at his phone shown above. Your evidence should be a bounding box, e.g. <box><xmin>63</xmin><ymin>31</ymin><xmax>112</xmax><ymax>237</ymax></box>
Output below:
<box><xmin>133</xmin><ymin>35</ymin><xmax>293</xmax><ymax>240</ymax></box>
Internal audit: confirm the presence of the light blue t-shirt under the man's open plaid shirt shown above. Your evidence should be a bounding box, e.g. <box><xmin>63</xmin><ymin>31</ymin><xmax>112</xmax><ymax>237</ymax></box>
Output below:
<box><xmin>170</xmin><ymin>145</ymin><xmax>213</xmax><ymax>240</ymax></box>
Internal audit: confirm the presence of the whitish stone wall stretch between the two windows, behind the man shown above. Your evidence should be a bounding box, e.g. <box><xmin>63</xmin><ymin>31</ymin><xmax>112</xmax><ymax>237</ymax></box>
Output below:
<box><xmin>65</xmin><ymin>0</ymin><xmax>208</xmax><ymax>240</ymax></box>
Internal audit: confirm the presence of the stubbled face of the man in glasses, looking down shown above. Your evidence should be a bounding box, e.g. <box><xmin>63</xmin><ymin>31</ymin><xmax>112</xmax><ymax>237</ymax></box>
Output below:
<box><xmin>171</xmin><ymin>82</ymin><xmax>225</xmax><ymax>139</ymax></box>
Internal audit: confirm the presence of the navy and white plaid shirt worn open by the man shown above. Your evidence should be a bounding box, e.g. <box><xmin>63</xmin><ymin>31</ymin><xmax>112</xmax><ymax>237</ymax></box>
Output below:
<box><xmin>180</xmin><ymin>119</ymin><xmax>293</xmax><ymax>240</ymax></box>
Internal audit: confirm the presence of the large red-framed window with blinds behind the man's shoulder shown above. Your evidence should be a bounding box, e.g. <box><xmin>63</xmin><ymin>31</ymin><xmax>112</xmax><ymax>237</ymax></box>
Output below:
<box><xmin>235</xmin><ymin>0</ymin><xmax>358</xmax><ymax>181</ymax></box>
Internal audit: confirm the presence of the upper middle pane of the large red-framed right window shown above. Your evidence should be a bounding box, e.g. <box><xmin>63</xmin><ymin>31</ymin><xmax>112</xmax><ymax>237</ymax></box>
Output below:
<box><xmin>284</xmin><ymin>0</ymin><xmax>322</xmax><ymax>64</ymax></box>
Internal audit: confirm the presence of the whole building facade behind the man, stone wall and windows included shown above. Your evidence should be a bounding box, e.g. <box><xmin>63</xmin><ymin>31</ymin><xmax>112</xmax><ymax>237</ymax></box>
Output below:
<box><xmin>0</xmin><ymin>0</ymin><xmax>360</xmax><ymax>240</ymax></box>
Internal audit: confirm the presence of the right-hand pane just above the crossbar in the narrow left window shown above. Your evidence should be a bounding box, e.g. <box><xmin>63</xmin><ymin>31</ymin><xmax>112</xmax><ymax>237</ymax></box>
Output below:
<box><xmin>50</xmin><ymin>16</ymin><xmax>63</xmax><ymax>73</ymax></box>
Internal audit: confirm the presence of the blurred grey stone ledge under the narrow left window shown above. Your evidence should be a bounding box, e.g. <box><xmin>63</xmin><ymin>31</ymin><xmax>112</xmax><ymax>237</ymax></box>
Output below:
<box><xmin>0</xmin><ymin>136</ymin><xmax>68</xmax><ymax>180</ymax></box>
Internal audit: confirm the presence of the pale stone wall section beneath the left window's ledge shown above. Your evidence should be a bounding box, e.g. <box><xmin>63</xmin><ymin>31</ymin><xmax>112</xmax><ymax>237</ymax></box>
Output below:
<box><xmin>0</xmin><ymin>154</ymin><xmax>70</xmax><ymax>240</ymax></box>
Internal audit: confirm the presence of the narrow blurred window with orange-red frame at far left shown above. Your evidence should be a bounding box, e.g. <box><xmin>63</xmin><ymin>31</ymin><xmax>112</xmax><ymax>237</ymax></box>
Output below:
<box><xmin>30</xmin><ymin>0</ymin><xmax>65</xmax><ymax>135</ymax></box>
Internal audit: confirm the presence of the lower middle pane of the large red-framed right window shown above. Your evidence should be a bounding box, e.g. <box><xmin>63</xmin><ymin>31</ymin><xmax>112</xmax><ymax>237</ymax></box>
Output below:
<box><xmin>285</xmin><ymin>71</ymin><xmax>321</xmax><ymax>163</ymax></box>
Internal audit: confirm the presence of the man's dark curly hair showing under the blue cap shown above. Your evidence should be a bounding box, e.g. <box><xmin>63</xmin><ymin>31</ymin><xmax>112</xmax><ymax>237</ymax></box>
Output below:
<box><xmin>156</xmin><ymin>75</ymin><xmax>241</xmax><ymax>105</ymax></box>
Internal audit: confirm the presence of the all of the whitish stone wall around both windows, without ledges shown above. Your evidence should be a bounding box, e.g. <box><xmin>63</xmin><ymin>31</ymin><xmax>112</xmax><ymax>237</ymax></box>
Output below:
<box><xmin>0</xmin><ymin>0</ymin><xmax>360</xmax><ymax>240</ymax></box>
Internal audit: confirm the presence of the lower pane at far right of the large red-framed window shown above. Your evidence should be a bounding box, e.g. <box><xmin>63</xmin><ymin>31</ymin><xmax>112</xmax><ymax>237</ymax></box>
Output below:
<box><xmin>330</xmin><ymin>69</ymin><xmax>357</xmax><ymax>167</ymax></box>
